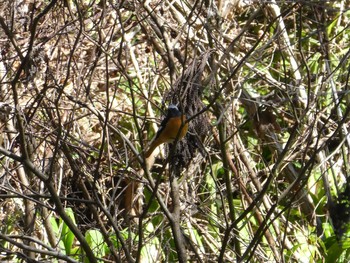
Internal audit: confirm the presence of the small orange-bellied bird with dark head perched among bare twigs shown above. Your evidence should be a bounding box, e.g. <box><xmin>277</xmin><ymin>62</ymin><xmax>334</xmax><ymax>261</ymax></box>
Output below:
<box><xmin>145</xmin><ymin>104</ymin><xmax>188</xmax><ymax>158</ymax></box>
